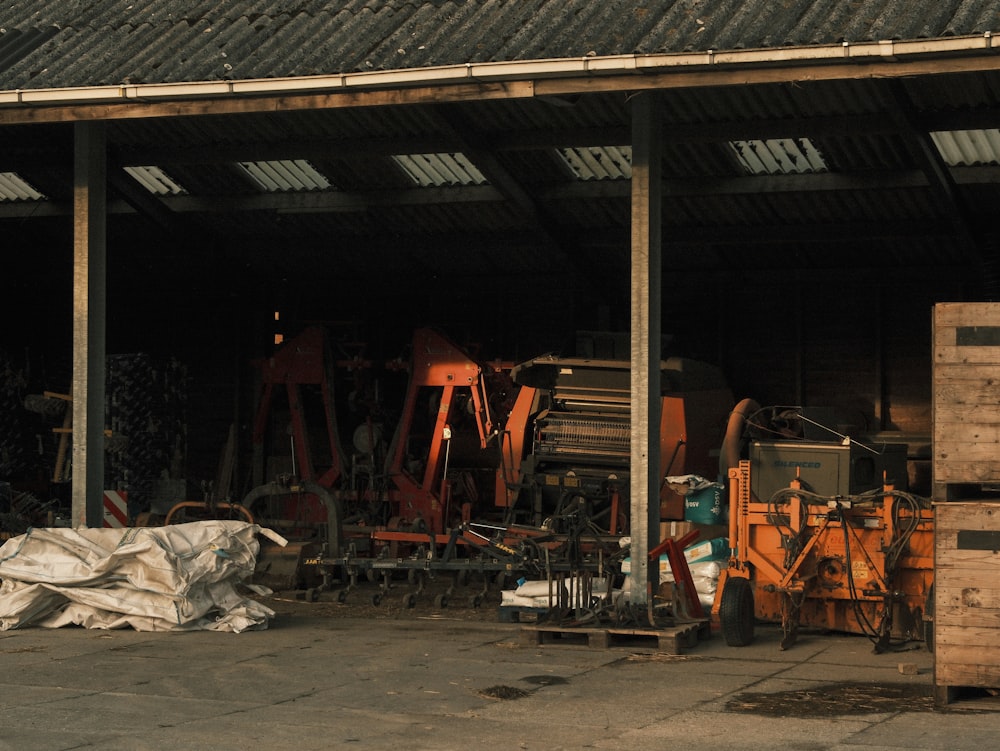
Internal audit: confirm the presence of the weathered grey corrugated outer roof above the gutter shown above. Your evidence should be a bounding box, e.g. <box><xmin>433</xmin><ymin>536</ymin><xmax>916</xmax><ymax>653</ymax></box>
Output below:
<box><xmin>0</xmin><ymin>0</ymin><xmax>1000</xmax><ymax>89</ymax></box>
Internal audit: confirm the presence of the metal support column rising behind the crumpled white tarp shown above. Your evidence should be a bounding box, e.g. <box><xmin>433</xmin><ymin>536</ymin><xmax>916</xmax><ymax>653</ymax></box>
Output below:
<box><xmin>72</xmin><ymin>122</ymin><xmax>107</xmax><ymax>527</ymax></box>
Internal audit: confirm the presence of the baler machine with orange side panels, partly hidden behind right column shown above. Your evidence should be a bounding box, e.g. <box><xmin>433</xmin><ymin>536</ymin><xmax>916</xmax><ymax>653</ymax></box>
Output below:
<box><xmin>496</xmin><ymin>356</ymin><xmax>733</xmax><ymax>535</ymax></box>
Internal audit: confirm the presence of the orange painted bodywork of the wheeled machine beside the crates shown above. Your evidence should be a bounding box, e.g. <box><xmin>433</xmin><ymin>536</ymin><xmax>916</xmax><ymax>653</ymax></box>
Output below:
<box><xmin>713</xmin><ymin>461</ymin><xmax>934</xmax><ymax>639</ymax></box>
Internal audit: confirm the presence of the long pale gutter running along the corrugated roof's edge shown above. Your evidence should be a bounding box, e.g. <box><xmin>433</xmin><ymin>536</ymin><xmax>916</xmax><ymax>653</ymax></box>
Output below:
<box><xmin>0</xmin><ymin>32</ymin><xmax>1000</xmax><ymax>108</ymax></box>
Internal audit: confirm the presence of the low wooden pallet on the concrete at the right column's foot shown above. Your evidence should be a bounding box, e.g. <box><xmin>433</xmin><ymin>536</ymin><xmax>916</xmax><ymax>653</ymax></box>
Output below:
<box><xmin>521</xmin><ymin>619</ymin><xmax>711</xmax><ymax>655</ymax></box>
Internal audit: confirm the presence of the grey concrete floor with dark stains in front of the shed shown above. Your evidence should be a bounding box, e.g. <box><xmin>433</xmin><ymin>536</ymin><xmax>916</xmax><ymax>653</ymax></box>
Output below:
<box><xmin>0</xmin><ymin>599</ymin><xmax>1000</xmax><ymax>751</ymax></box>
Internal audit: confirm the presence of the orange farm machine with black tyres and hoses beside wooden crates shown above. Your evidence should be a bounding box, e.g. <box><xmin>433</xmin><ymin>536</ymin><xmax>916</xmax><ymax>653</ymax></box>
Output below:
<box><xmin>713</xmin><ymin>441</ymin><xmax>934</xmax><ymax>652</ymax></box>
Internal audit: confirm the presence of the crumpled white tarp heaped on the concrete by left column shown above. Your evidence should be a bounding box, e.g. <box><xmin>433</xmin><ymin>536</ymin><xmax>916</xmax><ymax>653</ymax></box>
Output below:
<box><xmin>0</xmin><ymin>520</ymin><xmax>286</xmax><ymax>633</ymax></box>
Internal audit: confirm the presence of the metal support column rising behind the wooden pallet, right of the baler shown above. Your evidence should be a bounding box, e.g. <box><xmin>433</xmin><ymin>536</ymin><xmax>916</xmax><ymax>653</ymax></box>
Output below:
<box><xmin>629</xmin><ymin>92</ymin><xmax>663</xmax><ymax>604</ymax></box>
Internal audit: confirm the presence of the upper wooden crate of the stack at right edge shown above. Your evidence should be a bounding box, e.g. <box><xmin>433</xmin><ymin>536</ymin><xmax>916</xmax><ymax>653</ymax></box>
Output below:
<box><xmin>932</xmin><ymin>303</ymin><xmax>1000</xmax><ymax>500</ymax></box>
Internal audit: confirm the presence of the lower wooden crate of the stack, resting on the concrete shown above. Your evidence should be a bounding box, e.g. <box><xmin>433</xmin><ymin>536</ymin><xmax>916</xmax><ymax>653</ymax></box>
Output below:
<box><xmin>933</xmin><ymin>501</ymin><xmax>1000</xmax><ymax>705</ymax></box>
